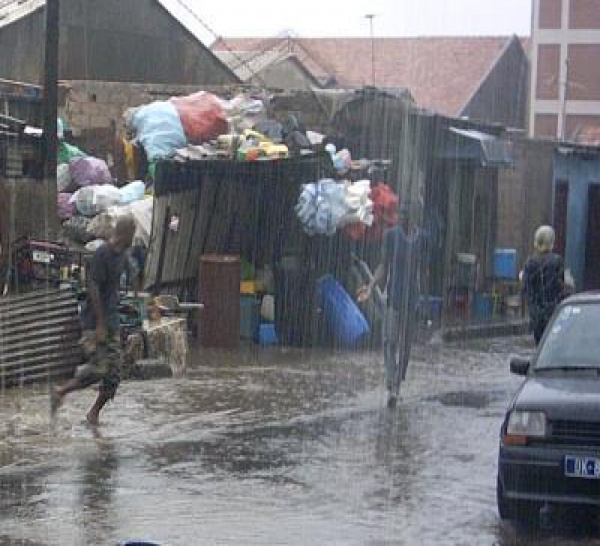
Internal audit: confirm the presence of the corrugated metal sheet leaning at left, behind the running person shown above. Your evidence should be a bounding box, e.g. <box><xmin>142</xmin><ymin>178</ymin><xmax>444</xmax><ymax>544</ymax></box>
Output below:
<box><xmin>0</xmin><ymin>290</ymin><xmax>82</xmax><ymax>386</ymax></box>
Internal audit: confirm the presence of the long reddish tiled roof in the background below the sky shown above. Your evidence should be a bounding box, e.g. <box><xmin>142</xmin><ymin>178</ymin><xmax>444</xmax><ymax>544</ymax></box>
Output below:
<box><xmin>212</xmin><ymin>36</ymin><xmax>528</xmax><ymax>116</ymax></box>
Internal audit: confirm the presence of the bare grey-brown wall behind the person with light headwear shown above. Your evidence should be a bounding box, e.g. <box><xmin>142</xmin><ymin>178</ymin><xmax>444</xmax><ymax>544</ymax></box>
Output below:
<box><xmin>497</xmin><ymin>136</ymin><xmax>555</xmax><ymax>265</ymax></box>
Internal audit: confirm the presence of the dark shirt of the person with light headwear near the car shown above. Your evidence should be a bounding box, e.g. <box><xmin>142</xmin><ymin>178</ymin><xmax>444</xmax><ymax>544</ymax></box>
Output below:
<box><xmin>523</xmin><ymin>253</ymin><xmax>564</xmax><ymax>316</ymax></box>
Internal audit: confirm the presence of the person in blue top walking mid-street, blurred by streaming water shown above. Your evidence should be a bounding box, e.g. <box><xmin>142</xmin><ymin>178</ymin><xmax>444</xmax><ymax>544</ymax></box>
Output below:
<box><xmin>357</xmin><ymin>205</ymin><xmax>424</xmax><ymax>408</ymax></box>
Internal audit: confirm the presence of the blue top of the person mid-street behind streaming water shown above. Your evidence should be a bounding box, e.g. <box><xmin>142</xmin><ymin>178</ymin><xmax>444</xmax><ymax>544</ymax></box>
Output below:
<box><xmin>382</xmin><ymin>226</ymin><xmax>424</xmax><ymax>311</ymax></box>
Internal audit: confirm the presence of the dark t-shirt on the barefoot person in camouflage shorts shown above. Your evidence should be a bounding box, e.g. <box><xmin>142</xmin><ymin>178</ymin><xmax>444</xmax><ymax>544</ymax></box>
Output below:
<box><xmin>82</xmin><ymin>244</ymin><xmax>128</xmax><ymax>332</ymax></box>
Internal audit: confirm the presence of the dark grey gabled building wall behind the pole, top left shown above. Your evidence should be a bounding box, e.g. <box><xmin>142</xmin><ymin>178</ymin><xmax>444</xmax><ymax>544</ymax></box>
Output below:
<box><xmin>0</xmin><ymin>0</ymin><xmax>237</xmax><ymax>85</ymax></box>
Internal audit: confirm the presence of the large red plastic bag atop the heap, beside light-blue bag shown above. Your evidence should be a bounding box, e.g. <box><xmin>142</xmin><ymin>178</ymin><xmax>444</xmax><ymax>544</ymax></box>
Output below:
<box><xmin>170</xmin><ymin>91</ymin><xmax>229</xmax><ymax>144</ymax></box>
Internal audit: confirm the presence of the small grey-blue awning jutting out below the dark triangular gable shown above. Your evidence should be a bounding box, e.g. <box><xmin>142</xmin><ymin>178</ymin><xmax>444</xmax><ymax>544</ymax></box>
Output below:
<box><xmin>442</xmin><ymin>127</ymin><xmax>513</xmax><ymax>167</ymax></box>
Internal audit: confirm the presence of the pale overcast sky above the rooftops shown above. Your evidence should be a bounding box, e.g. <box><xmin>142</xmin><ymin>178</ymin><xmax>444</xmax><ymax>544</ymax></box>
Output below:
<box><xmin>165</xmin><ymin>0</ymin><xmax>531</xmax><ymax>44</ymax></box>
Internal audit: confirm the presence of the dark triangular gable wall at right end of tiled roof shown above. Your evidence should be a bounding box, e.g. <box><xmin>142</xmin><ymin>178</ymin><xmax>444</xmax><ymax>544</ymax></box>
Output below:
<box><xmin>459</xmin><ymin>36</ymin><xmax>529</xmax><ymax>129</ymax></box>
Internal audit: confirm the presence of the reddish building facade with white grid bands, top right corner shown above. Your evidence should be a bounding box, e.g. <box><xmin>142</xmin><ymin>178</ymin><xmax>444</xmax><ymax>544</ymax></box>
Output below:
<box><xmin>529</xmin><ymin>0</ymin><xmax>600</xmax><ymax>141</ymax></box>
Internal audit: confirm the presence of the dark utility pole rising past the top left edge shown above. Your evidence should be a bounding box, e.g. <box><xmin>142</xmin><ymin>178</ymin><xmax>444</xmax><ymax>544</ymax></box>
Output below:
<box><xmin>42</xmin><ymin>0</ymin><xmax>60</xmax><ymax>230</ymax></box>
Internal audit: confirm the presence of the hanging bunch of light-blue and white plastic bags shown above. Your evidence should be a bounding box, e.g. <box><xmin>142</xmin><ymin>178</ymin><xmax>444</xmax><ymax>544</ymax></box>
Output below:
<box><xmin>295</xmin><ymin>179</ymin><xmax>373</xmax><ymax>236</ymax></box>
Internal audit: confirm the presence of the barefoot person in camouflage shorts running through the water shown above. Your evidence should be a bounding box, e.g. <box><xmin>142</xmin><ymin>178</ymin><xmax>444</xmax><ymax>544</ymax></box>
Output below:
<box><xmin>50</xmin><ymin>216</ymin><xmax>135</xmax><ymax>426</ymax></box>
